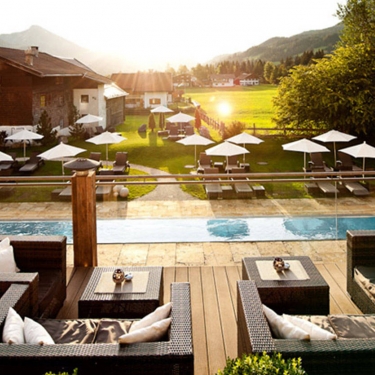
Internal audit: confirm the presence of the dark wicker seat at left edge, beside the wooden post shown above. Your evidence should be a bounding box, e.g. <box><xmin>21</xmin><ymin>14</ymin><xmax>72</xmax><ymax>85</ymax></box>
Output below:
<box><xmin>0</xmin><ymin>236</ymin><xmax>66</xmax><ymax>318</ymax></box>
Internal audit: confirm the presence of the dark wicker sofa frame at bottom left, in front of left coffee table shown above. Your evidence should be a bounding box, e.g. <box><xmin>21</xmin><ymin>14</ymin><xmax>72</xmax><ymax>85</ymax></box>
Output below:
<box><xmin>0</xmin><ymin>283</ymin><xmax>194</xmax><ymax>375</ymax></box>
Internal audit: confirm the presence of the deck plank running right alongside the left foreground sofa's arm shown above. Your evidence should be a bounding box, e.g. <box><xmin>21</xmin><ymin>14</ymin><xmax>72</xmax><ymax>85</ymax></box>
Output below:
<box><xmin>189</xmin><ymin>267</ymin><xmax>209</xmax><ymax>375</ymax></box>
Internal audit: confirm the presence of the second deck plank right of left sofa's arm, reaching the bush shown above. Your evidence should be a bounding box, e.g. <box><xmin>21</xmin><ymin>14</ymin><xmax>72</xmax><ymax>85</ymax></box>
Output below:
<box><xmin>201</xmin><ymin>267</ymin><xmax>226</xmax><ymax>374</ymax></box>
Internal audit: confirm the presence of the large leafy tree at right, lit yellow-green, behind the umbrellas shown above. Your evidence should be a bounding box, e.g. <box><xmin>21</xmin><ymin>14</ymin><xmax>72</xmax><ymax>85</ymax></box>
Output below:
<box><xmin>274</xmin><ymin>0</ymin><xmax>375</xmax><ymax>135</ymax></box>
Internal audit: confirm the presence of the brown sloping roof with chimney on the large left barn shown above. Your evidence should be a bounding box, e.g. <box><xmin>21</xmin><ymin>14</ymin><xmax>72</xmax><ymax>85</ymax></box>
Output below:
<box><xmin>0</xmin><ymin>47</ymin><xmax>111</xmax><ymax>84</ymax></box>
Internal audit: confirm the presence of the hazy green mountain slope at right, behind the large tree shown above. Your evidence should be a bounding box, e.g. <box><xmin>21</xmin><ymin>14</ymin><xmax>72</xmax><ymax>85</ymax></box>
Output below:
<box><xmin>209</xmin><ymin>23</ymin><xmax>343</xmax><ymax>64</ymax></box>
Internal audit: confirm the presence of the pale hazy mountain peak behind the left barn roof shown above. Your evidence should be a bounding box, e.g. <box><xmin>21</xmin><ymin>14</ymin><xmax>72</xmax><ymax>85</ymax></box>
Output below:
<box><xmin>0</xmin><ymin>26</ymin><xmax>138</xmax><ymax>75</ymax></box>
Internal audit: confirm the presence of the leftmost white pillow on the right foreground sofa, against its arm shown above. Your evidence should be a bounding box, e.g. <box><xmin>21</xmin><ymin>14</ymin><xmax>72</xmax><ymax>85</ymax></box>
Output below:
<box><xmin>263</xmin><ymin>305</ymin><xmax>310</xmax><ymax>340</ymax></box>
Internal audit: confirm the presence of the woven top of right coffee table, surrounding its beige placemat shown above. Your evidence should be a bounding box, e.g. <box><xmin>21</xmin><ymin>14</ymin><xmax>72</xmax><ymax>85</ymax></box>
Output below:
<box><xmin>242</xmin><ymin>256</ymin><xmax>328</xmax><ymax>288</ymax></box>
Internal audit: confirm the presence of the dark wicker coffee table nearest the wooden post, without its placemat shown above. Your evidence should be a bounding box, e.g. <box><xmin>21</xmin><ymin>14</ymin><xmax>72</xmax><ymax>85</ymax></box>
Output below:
<box><xmin>78</xmin><ymin>267</ymin><xmax>163</xmax><ymax>318</ymax></box>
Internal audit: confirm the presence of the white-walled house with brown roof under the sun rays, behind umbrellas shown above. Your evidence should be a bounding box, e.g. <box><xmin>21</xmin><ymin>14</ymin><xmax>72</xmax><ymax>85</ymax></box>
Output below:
<box><xmin>111</xmin><ymin>72</ymin><xmax>173</xmax><ymax>108</ymax></box>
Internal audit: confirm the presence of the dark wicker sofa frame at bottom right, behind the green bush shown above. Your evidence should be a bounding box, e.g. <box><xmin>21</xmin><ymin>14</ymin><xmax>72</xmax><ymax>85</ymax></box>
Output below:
<box><xmin>237</xmin><ymin>280</ymin><xmax>375</xmax><ymax>375</ymax></box>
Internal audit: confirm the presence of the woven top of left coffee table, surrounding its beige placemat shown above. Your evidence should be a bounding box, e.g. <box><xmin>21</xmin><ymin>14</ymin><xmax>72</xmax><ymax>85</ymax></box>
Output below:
<box><xmin>80</xmin><ymin>266</ymin><xmax>163</xmax><ymax>301</ymax></box>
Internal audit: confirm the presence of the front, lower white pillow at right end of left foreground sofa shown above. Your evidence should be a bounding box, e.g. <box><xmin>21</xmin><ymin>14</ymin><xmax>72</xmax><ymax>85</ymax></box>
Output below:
<box><xmin>118</xmin><ymin>318</ymin><xmax>172</xmax><ymax>344</ymax></box>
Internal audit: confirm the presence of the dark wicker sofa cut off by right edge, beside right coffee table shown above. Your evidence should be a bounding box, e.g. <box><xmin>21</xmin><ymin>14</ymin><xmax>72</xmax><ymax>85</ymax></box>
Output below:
<box><xmin>346</xmin><ymin>230</ymin><xmax>375</xmax><ymax>314</ymax></box>
